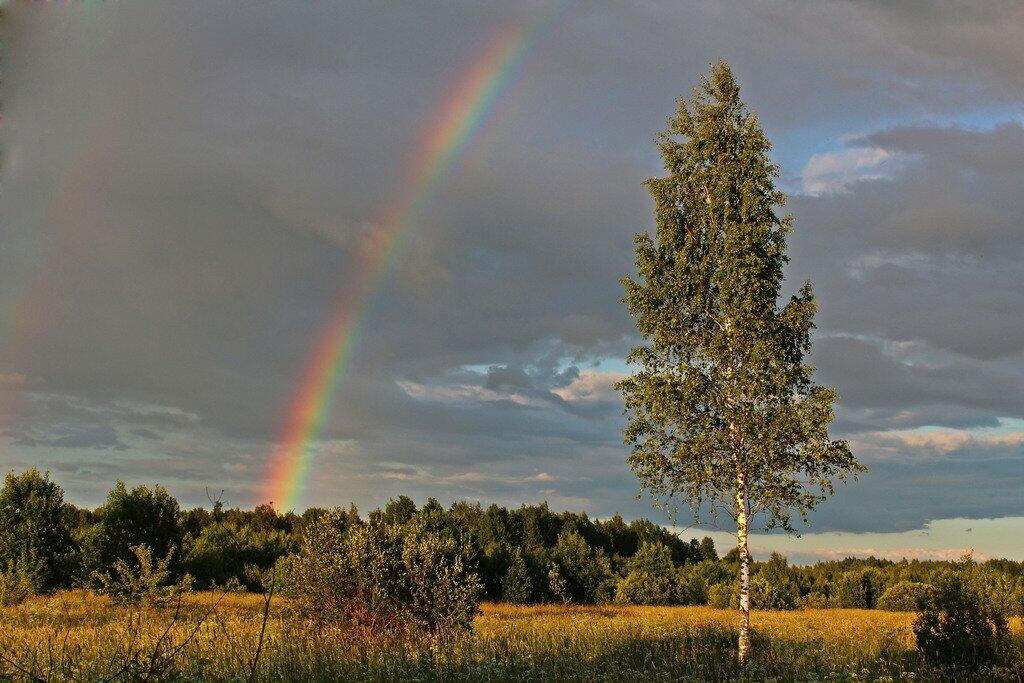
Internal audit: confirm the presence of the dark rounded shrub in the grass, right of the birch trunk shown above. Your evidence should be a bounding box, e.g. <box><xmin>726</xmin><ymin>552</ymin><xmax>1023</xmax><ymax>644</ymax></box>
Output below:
<box><xmin>913</xmin><ymin>572</ymin><xmax>1007</xmax><ymax>672</ymax></box>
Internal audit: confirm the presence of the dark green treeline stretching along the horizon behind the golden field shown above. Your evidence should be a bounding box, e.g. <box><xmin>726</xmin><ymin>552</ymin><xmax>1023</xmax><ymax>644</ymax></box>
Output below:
<box><xmin>6</xmin><ymin>469</ymin><xmax>1024</xmax><ymax>614</ymax></box>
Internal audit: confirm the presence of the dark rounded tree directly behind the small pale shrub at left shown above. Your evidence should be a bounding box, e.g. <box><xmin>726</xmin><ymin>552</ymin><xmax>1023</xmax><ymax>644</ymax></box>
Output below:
<box><xmin>83</xmin><ymin>481</ymin><xmax>183</xmax><ymax>577</ymax></box>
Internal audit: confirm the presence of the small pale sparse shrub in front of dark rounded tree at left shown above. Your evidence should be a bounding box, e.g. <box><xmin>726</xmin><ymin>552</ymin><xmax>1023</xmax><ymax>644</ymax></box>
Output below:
<box><xmin>93</xmin><ymin>545</ymin><xmax>191</xmax><ymax>604</ymax></box>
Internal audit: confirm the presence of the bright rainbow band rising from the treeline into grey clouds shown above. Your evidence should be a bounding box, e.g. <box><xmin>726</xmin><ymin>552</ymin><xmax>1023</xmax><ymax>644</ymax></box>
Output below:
<box><xmin>258</xmin><ymin>21</ymin><xmax>552</xmax><ymax>510</ymax></box>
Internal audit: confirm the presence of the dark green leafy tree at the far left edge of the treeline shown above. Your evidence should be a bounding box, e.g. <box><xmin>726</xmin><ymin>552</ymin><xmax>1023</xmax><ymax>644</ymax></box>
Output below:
<box><xmin>0</xmin><ymin>468</ymin><xmax>76</xmax><ymax>592</ymax></box>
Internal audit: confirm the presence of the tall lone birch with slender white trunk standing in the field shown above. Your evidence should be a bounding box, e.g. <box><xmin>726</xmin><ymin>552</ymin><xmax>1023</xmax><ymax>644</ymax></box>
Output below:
<box><xmin>617</xmin><ymin>61</ymin><xmax>862</xmax><ymax>661</ymax></box>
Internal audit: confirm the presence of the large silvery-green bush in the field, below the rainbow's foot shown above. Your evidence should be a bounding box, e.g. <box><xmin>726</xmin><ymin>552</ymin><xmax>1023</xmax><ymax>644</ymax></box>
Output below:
<box><xmin>288</xmin><ymin>512</ymin><xmax>482</xmax><ymax>640</ymax></box>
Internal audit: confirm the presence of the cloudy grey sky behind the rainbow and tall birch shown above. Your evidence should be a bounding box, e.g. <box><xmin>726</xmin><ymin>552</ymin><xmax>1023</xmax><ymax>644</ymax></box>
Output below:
<box><xmin>0</xmin><ymin>0</ymin><xmax>1024</xmax><ymax>561</ymax></box>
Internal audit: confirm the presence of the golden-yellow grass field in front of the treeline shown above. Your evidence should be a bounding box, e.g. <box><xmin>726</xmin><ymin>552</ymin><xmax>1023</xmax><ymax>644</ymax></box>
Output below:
<box><xmin>0</xmin><ymin>592</ymin><xmax>1024</xmax><ymax>681</ymax></box>
